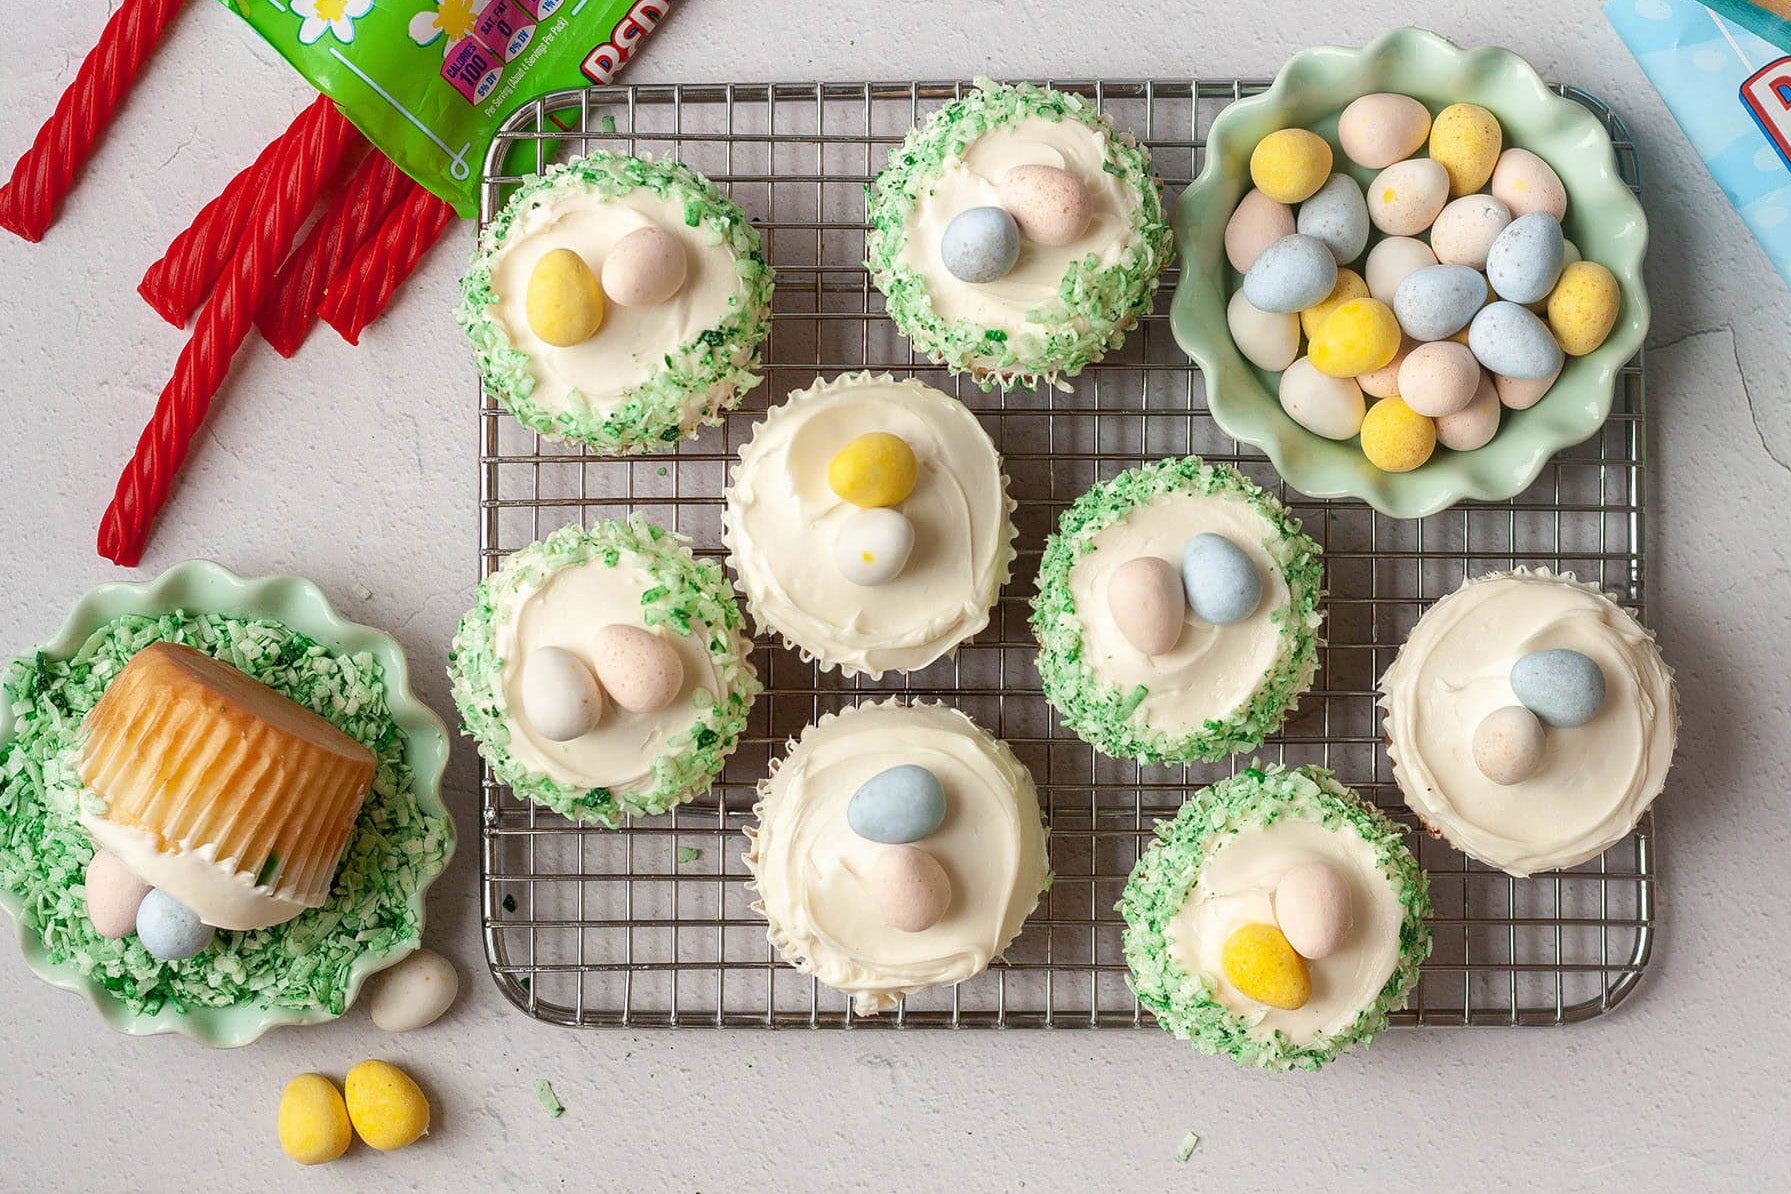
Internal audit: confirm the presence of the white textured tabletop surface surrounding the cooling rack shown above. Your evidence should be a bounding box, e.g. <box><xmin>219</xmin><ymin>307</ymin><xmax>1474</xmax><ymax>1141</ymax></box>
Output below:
<box><xmin>0</xmin><ymin>0</ymin><xmax>1791</xmax><ymax>1190</ymax></box>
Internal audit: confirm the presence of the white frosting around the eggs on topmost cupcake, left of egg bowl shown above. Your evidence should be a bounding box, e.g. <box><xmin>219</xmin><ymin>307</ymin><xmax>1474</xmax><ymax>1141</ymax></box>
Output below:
<box><xmin>897</xmin><ymin>116</ymin><xmax>1141</xmax><ymax>365</ymax></box>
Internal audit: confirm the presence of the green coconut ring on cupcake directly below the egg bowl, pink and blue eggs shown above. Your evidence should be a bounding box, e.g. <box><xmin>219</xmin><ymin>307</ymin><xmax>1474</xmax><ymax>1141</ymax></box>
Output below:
<box><xmin>1032</xmin><ymin>456</ymin><xmax>1324</xmax><ymax>763</ymax></box>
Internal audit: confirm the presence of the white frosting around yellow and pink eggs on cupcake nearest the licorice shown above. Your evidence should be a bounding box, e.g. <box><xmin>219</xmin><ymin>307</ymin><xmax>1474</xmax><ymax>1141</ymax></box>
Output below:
<box><xmin>491</xmin><ymin>186</ymin><xmax>745</xmax><ymax>414</ymax></box>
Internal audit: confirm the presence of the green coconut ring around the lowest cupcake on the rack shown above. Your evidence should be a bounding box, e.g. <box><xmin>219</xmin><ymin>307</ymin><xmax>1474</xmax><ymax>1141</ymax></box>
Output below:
<box><xmin>1118</xmin><ymin>764</ymin><xmax>1431</xmax><ymax>1070</ymax></box>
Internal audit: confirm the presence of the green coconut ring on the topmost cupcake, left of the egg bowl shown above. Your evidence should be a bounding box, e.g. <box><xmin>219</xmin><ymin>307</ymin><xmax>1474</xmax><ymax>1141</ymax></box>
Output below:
<box><xmin>865</xmin><ymin>79</ymin><xmax>1173</xmax><ymax>390</ymax></box>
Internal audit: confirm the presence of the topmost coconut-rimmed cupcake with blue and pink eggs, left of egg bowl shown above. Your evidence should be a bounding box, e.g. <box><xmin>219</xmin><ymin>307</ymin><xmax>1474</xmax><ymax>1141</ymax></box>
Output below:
<box><xmin>867</xmin><ymin>79</ymin><xmax>1171</xmax><ymax>390</ymax></box>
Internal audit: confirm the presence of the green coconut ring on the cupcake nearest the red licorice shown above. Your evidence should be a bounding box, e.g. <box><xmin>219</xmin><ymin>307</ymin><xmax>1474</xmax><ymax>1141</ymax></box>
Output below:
<box><xmin>455</xmin><ymin>150</ymin><xmax>772</xmax><ymax>453</ymax></box>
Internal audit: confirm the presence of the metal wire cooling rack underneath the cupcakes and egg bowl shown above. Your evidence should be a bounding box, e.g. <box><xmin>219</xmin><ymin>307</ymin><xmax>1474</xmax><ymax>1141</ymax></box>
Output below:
<box><xmin>478</xmin><ymin>81</ymin><xmax>1655</xmax><ymax>1028</ymax></box>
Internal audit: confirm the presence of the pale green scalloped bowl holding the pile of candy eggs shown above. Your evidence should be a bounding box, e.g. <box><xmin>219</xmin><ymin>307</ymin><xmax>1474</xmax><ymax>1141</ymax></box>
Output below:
<box><xmin>1170</xmin><ymin>29</ymin><xmax>1648</xmax><ymax>517</ymax></box>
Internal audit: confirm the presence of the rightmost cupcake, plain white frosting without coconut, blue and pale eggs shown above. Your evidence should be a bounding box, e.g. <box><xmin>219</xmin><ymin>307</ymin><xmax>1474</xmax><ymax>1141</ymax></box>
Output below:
<box><xmin>1381</xmin><ymin>567</ymin><xmax>1678</xmax><ymax>875</ymax></box>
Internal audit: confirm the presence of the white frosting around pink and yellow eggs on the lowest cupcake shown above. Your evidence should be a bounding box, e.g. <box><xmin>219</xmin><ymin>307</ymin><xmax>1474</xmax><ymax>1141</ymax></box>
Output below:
<box><xmin>1168</xmin><ymin>818</ymin><xmax>1404</xmax><ymax>1045</ymax></box>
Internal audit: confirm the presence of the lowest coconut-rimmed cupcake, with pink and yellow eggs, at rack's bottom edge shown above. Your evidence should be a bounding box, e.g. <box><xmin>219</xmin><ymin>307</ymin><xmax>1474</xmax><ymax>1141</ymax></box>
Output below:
<box><xmin>1119</xmin><ymin>764</ymin><xmax>1431</xmax><ymax>1070</ymax></box>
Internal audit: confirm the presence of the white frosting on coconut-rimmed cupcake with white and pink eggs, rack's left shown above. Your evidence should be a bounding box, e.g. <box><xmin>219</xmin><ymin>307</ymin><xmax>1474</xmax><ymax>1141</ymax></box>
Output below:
<box><xmin>493</xmin><ymin>551</ymin><xmax>722</xmax><ymax>791</ymax></box>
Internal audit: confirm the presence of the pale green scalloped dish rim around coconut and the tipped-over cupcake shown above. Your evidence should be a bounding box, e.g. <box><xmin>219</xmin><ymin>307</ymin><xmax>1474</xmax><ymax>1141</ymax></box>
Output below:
<box><xmin>0</xmin><ymin>560</ymin><xmax>455</xmax><ymax>1049</ymax></box>
